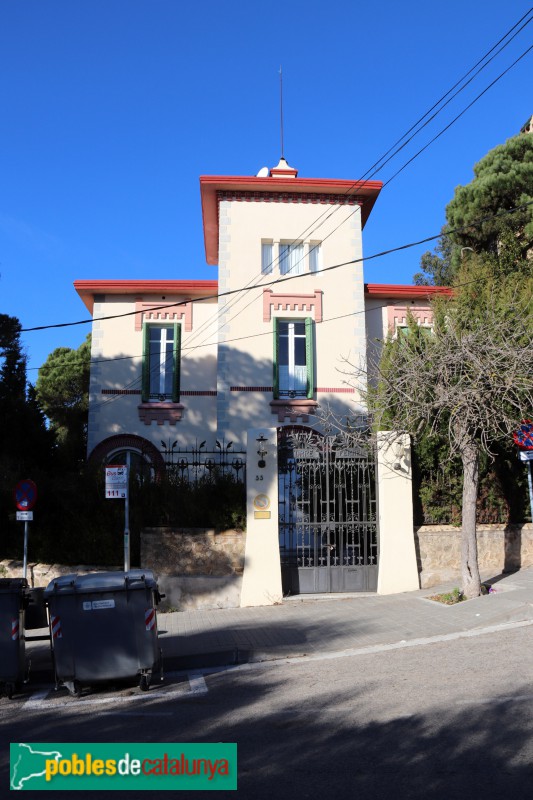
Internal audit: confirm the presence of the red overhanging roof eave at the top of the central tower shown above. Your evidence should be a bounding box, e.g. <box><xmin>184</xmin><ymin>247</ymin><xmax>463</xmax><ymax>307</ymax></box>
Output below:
<box><xmin>200</xmin><ymin>175</ymin><xmax>383</xmax><ymax>265</ymax></box>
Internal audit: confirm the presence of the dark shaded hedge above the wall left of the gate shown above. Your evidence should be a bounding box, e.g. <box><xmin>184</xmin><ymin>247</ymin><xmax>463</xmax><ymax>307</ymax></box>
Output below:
<box><xmin>0</xmin><ymin>466</ymin><xmax>246</xmax><ymax>567</ymax></box>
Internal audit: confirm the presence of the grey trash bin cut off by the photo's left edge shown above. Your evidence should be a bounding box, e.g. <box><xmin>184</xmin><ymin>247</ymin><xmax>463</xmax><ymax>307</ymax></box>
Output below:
<box><xmin>0</xmin><ymin>578</ymin><xmax>28</xmax><ymax>697</ymax></box>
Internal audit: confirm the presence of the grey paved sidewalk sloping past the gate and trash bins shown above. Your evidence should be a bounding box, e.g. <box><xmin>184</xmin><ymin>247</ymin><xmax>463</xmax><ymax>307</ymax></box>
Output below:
<box><xmin>26</xmin><ymin>568</ymin><xmax>533</xmax><ymax>681</ymax></box>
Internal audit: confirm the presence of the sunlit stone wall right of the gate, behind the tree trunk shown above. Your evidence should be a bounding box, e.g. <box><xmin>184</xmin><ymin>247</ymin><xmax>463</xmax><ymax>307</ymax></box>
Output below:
<box><xmin>415</xmin><ymin>523</ymin><xmax>533</xmax><ymax>589</ymax></box>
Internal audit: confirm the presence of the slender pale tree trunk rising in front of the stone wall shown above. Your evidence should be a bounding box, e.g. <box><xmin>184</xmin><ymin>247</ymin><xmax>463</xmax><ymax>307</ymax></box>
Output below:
<box><xmin>460</xmin><ymin>431</ymin><xmax>481</xmax><ymax>598</ymax></box>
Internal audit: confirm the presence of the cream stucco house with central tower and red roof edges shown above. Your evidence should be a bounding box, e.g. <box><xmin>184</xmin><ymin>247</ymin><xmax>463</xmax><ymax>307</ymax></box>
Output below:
<box><xmin>74</xmin><ymin>160</ymin><xmax>440</xmax><ymax>458</ymax></box>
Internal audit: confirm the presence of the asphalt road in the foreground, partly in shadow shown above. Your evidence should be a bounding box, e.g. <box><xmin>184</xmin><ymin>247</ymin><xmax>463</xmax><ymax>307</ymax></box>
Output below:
<box><xmin>0</xmin><ymin>624</ymin><xmax>533</xmax><ymax>800</ymax></box>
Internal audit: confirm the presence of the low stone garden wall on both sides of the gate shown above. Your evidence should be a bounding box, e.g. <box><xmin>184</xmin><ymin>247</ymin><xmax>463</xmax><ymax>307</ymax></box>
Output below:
<box><xmin>5</xmin><ymin>523</ymin><xmax>533</xmax><ymax>611</ymax></box>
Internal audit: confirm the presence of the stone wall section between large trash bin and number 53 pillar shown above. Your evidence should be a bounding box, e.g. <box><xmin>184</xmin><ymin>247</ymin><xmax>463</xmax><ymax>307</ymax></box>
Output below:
<box><xmin>141</xmin><ymin>528</ymin><xmax>246</xmax><ymax>611</ymax></box>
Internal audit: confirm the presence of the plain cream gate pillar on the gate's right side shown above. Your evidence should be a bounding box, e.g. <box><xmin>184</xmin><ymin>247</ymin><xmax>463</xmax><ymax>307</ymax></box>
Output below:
<box><xmin>377</xmin><ymin>431</ymin><xmax>420</xmax><ymax>594</ymax></box>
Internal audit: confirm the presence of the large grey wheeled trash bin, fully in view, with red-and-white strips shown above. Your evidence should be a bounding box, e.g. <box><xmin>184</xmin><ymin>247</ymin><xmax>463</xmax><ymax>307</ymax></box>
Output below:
<box><xmin>44</xmin><ymin>569</ymin><xmax>161</xmax><ymax>695</ymax></box>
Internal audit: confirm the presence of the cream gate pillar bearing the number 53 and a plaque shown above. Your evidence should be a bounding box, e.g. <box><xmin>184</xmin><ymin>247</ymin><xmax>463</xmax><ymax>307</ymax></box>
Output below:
<box><xmin>241</xmin><ymin>428</ymin><xmax>283</xmax><ymax>607</ymax></box>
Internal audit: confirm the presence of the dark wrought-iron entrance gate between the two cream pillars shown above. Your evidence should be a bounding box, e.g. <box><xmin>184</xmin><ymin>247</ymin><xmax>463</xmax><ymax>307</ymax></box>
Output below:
<box><xmin>279</xmin><ymin>432</ymin><xmax>378</xmax><ymax>594</ymax></box>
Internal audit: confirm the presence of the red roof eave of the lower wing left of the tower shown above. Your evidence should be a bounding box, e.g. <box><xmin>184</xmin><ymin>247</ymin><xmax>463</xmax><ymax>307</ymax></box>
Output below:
<box><xmin>74</xmin><ymin>280</ymin><xmax>218</xmax><ymax>314</ymax></box>
